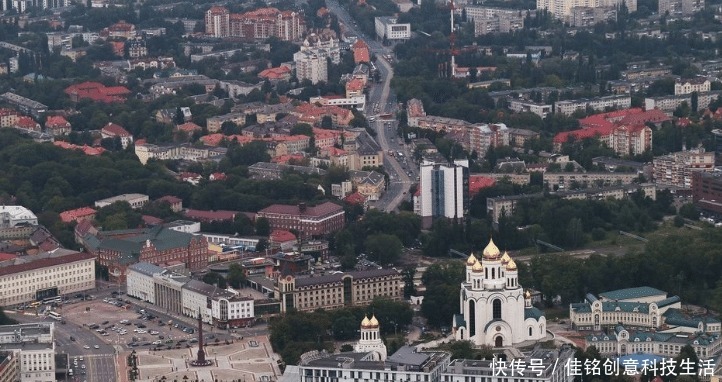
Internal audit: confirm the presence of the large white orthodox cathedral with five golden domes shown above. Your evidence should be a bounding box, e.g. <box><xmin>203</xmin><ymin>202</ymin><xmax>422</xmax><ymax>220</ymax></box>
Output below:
<box><xmin>452</xmin><ymin>240</ymin><xmax>546</xmax><ymax>347</ymax></box>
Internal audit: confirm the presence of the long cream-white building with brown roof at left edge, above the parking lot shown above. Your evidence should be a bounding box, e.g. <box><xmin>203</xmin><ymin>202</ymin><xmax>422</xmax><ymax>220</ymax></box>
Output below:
<box><xmin>0</xmin><ymin>249</ymin><xmax>95</xmax><ymax>306</ymax></box>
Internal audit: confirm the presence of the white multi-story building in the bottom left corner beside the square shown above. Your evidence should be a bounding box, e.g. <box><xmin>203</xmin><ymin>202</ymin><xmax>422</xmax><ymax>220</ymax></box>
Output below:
<box><xmin>0</xmin><ymin>322</ymin><xmax>55</xmax><ymax>382</ymax></box>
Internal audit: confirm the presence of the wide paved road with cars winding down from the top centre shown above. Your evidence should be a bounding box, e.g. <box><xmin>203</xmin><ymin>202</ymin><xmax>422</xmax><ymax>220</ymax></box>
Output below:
<box><xmin>326</xmin><ymin>0</ymin><xmax>418</xmax><ymax>212</ymax></box>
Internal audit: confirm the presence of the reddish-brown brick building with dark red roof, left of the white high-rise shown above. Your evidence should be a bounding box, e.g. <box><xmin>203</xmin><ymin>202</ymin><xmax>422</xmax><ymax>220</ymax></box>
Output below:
<box><xmin>257</xmin><ymin>202</ymin><xmax>346</xmax><ymax>238</ymax></box>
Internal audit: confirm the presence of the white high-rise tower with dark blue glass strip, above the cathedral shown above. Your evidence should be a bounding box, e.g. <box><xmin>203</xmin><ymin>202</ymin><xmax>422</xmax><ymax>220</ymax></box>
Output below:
<box><xmin>417</xmin><ymin>162</ymin><xmax>469</xmax><ymax>227</ymax></box>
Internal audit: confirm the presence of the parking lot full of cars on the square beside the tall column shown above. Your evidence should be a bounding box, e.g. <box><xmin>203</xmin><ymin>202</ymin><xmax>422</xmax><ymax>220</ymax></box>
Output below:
<box><xmin>57</xmin><ymin>296</ymin><xmax>207</xmax><ymax>350</ymax></box>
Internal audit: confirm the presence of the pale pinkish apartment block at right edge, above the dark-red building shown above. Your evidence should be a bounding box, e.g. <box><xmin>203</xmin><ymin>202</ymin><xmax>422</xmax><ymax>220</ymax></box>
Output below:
<box><xmin>652</xmin><ymin>147</ymin><xmax>714</xmax><ymax>189</ymax></box>
